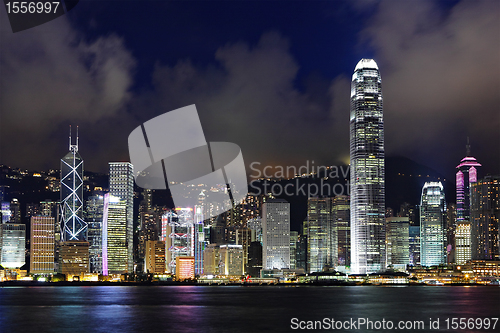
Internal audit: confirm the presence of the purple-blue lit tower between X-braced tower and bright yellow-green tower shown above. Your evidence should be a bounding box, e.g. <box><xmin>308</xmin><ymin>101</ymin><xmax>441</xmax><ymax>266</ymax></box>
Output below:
<box><xmin>85</xmin><ymin>195</ymin><xmax>104</xmax><ymax>274</ymax></box>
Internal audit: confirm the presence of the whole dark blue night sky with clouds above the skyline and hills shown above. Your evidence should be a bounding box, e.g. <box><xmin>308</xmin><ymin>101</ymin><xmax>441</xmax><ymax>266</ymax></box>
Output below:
<box><xmin>0</xmin><ymin>0</ymin><xmax>500</xmax><ymax>182</ymax></box>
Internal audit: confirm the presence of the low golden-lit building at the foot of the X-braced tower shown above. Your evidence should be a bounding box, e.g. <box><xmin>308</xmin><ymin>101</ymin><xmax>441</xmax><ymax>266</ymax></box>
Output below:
<box><xmin>59</xmin><ymin>241</ymin><xmax>89</xmax><ymax>280</ymax></box>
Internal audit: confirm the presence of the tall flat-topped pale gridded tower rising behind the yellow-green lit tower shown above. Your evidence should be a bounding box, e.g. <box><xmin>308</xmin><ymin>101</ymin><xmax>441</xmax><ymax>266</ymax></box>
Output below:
<box><xmin>109</xmin><ymin>162</ymin><xmax>134</xmax><ymax>273</ymax></box>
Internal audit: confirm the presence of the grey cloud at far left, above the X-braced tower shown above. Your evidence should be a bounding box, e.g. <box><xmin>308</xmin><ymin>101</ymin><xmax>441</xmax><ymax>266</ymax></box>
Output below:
<box><xmin>0</xmin><ymin>11</ymin><xmax>135</xmax><ymax>170</ymax></box>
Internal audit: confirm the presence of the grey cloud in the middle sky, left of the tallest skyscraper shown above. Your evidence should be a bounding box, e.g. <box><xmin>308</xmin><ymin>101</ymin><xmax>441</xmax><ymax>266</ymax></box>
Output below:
<box><xmin>133</xmin><ymin>32</ymin><xmax>348</xmax><ymax>170</ymax></box>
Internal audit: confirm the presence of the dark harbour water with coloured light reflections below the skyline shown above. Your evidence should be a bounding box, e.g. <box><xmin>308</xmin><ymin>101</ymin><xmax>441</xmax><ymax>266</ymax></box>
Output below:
<box><xmin>0</xmin><ymin>286</ymin><xmax>500</xmax><ymax>332</ymax></box>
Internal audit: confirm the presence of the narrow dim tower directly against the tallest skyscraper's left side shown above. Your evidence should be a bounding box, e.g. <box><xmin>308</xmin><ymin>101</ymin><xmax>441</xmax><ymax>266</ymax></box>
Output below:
<box><xmin>332</xmin><ymin>195</ymin><xmax>351</xmax><ymax>266</ymax></box>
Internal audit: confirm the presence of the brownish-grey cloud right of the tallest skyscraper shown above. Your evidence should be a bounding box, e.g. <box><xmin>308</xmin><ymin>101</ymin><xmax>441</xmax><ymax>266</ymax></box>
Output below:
<box><xmin>361</xmin><ymin>1</ymin><xmax>500</xmax><ymax>172</ymax></box>
